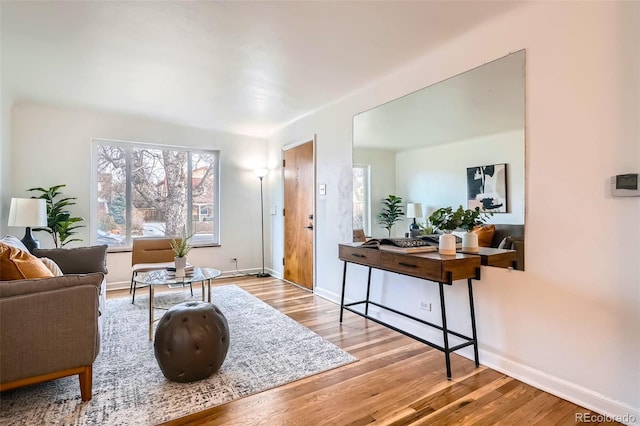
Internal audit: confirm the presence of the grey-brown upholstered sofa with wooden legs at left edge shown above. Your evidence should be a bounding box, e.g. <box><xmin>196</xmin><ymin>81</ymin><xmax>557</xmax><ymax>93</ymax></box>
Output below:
<box><xmin>0</xmin><ymin>246</ymin><xmax>106</xmax><ymax>401</ymax></box>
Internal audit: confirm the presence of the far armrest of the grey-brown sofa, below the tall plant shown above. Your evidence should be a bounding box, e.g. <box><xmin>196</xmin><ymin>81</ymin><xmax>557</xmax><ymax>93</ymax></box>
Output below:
<box><xmin>33</xmin><ymin>244</ymin><xmax>109</xmax><ymax>274</ymax></box>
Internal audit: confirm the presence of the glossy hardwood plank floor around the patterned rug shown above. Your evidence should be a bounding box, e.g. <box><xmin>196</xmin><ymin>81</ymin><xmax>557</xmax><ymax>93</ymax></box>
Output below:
<box><xmin>109</xmin><ymin>277</ymin><xmax>616</xmax><ymax>426</ymax></box>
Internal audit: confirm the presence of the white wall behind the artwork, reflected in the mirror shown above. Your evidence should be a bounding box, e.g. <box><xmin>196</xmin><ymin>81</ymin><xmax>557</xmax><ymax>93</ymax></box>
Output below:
<box><xmin>395</xmin><ymin>131</ymin><xmax>524</xmax><ymax>223</ymax></box>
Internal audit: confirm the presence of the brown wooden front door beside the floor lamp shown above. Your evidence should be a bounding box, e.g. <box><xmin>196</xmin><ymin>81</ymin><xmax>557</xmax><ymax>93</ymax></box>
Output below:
<box><xmin>283</xmin><ymin>141</ymin><xmax>314</xmax><ymax>290</ymax></box>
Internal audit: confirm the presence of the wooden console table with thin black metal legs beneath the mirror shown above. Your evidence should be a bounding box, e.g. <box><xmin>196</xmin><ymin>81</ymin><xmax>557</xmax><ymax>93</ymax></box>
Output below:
<box><xmin>338</xmin><ymin>243</ymin><xmax>492</xmax><ymax>379</ymax></box>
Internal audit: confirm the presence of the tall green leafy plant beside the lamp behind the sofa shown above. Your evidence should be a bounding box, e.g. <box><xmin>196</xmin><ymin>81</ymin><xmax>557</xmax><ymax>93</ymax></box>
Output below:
<box><xmin>27</xmin><ymin>185</ymin><xmax>84</xmax><ymax>248</ymax></box>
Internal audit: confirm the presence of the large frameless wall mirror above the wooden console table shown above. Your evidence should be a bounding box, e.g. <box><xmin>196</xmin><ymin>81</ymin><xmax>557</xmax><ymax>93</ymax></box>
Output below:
<box><xmin>353</xmin><ymin>50</ymin><xmax>525</xmax><ymax>269</ymax></box>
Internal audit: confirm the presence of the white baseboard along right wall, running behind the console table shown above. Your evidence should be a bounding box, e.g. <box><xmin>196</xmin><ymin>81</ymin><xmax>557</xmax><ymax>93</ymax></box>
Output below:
<box><xmin>315</xmin><ymin>288</ymin><xmax>640</xmax><ymax>426</ymax></box>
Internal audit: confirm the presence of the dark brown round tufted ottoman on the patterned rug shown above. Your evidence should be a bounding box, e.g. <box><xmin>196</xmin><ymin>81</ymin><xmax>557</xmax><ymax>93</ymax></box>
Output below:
<box><xmin>153</xmin><ymin>302</ymin><xmax>229</xmax><ymax>383</ymax></box>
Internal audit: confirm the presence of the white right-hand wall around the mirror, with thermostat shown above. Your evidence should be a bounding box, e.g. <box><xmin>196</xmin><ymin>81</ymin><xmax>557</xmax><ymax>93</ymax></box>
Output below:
<box><xmin>270</xmin><ymin>2</ymin><xmax>640</xmax><ymax>421</ymax></box>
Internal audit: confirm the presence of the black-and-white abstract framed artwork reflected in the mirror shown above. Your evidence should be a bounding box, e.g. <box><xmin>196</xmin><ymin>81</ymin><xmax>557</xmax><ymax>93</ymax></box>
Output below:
<box><xmin>467</xmin><ymin>164</ymin><xmax>508</xmax><ymax>213</ymax></box>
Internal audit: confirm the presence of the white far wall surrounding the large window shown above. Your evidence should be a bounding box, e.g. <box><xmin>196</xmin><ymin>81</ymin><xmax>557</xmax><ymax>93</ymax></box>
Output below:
<box><xmin>9</xmin><ymin>104</ymin><xmax>270</xmax><ymax>284</ymax></box>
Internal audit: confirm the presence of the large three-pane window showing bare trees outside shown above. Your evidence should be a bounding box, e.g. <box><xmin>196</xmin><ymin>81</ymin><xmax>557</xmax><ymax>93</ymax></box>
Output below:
<box><xmin>93</xmin><ymin>140</ymin><xmax>220</xmax><ymax>247</ymax></box>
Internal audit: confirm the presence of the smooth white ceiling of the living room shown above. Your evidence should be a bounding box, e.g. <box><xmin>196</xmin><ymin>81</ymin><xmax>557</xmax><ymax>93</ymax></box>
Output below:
<box><xmin>0</xmin><ymin>0</ymin><xmax>517</xmax><ymax>136</ymax></box>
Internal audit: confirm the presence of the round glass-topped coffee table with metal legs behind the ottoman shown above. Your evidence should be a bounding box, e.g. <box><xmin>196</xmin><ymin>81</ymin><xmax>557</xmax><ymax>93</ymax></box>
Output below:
<box><xmin>133</xmin><ymin>267</ymin><xmax>221</xmax><ymax>340</ymax></box>
